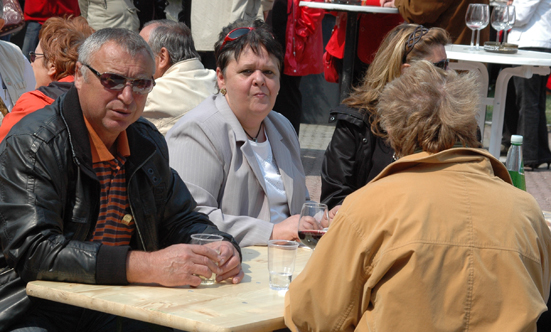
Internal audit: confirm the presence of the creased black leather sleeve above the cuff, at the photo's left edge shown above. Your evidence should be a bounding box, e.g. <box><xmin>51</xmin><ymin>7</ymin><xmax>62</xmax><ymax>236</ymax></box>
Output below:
<box><xmin>0</xmin><ymin>132</ymin><xmax>104</xmax><ymax>283</ymax></box>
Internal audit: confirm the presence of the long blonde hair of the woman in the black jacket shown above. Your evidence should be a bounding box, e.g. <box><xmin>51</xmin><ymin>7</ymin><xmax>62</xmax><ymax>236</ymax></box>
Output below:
<box><xmin>343</xmin><ymin>23</ymin><xmax>450</xmax><ymax>137</ymax></box>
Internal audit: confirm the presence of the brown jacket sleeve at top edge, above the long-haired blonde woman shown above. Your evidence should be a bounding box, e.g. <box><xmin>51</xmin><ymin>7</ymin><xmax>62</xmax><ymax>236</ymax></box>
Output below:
<box><xmin>394</xmin><ymin>0</ymin><xmax>457</xmax><ymax>24</ymax></box>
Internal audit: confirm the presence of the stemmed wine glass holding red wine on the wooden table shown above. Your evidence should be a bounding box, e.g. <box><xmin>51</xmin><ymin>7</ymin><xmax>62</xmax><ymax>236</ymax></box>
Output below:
<box><xmin>298</xmin><ymin>202</ymin><xmax>329</xmax><ymax>249</ymax></box>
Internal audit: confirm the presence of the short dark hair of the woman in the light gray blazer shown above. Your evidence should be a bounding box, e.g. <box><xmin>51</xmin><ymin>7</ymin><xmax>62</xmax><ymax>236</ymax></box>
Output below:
<box><xmin>214</xmin><ymin>20</ymin><xmax>283</xmax><ymax>72</ymax></box>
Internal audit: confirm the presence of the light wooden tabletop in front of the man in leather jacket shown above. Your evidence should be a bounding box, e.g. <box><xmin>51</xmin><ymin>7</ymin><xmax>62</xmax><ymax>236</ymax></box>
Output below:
<box><xmin>27</xmin><ymin>247</ymin><xmax>312</xmax><ymax>331</ymax></box>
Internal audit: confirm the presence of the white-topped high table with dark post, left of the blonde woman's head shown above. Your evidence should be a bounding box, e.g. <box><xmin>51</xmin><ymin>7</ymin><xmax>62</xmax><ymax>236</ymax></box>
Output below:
<box><xmin>299</xmin><ymin>1</ymin><xmax>398</xmax><ymax>100</ymax></box>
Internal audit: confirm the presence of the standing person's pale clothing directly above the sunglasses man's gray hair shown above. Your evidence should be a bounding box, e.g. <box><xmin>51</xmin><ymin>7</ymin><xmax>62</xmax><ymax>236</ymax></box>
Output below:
<box><xmin>78</xmin><ymin>0</ymin><xmax>140</xmax><ymax>31</ymax></box>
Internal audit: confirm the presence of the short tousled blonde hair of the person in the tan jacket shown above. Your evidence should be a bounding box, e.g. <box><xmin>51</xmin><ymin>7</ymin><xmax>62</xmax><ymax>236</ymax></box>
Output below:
<box><xmin>378</xmin><ymin>60</ymin><xmax>480</xmax><ymax>157</ymax></box>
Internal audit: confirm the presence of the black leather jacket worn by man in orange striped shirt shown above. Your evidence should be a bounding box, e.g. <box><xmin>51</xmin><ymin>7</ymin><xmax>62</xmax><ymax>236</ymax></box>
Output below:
<box><xmin>0</xmin><ymin>88</ymin><xmax>239</xmax><ymax>331</ymax></box>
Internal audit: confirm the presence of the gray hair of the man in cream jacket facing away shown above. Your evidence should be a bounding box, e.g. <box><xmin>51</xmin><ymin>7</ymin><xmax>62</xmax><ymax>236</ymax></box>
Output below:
<box><xmin>144</xmin><ymin>20</ymin><xmax>201</xmax><ymax>66</ymax></box>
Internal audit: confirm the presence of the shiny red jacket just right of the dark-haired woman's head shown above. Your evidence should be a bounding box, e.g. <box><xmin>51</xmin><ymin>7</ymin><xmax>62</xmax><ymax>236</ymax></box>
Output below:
<box><xmin>283</xmin><ymin>0</ymin><xmax>325</xmax><ymax>76</ymax></box>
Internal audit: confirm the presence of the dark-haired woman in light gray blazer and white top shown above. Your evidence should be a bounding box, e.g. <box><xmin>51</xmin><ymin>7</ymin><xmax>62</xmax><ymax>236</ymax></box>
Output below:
<box><xmin>166</xmin><ymin>20</ymin><xmax>309</xmax><ymax>246</ymax></box>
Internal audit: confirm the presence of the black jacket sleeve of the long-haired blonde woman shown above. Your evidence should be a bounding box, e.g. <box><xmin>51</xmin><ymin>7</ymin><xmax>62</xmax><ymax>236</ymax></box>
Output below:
<box><xmin>320</xmin><ymin>120</ymin><xmax>369</xmax><ymax>209</ymax></box>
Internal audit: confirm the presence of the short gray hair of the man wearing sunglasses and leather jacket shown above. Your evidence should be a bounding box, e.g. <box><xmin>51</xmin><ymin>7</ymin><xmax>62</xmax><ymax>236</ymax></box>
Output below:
<box><xmin>78</xmin><ymin>28</ymin><xmax>155</xmax><ymax>79</ymax></box>
